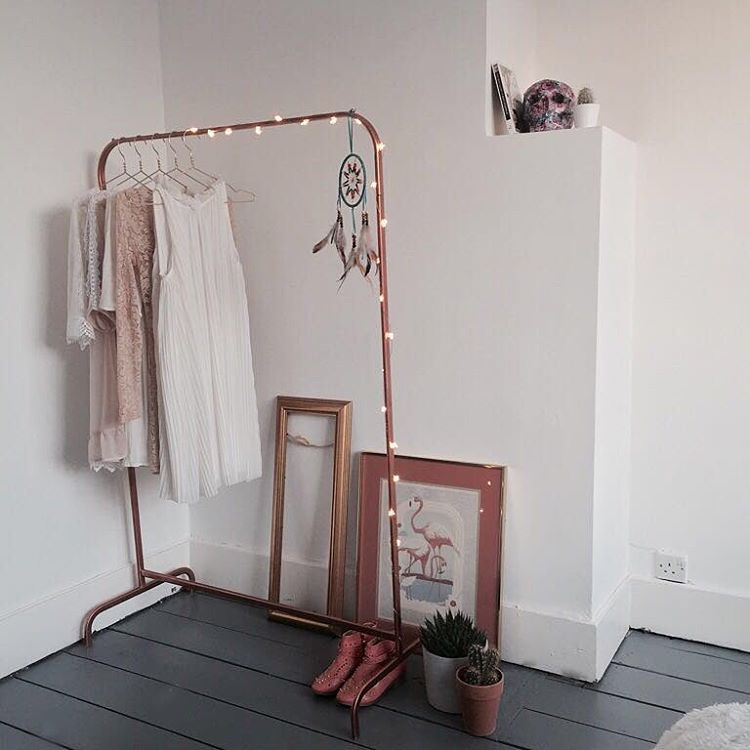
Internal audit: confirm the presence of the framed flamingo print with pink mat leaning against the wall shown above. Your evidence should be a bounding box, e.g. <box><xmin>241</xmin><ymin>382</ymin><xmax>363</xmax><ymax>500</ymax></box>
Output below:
<box><xmin>357</xmin><ymin>453</ymin><xmax>504</xmax><ymax>643</ymax></box>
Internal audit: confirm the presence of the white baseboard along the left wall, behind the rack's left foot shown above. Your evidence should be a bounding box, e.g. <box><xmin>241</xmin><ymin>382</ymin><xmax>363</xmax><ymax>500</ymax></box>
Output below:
<box><xmin>0</xmin><ymin>540</ymin><xmax>190</xmax><ymax>677</ymax></box>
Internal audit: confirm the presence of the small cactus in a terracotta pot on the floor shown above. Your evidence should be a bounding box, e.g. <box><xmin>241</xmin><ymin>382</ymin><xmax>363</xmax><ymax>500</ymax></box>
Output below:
<box><xmin>456</xmin><ymin>646</ymin><xmax>505</xmax><ymax>737</ymax></box>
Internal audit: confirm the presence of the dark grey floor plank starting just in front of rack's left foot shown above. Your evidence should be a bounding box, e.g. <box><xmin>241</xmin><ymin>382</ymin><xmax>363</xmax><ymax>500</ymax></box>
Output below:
<box><xmin>24</xmin><ymin>653</ymin><xmax>362</xmax><ymax>750</ymax></box>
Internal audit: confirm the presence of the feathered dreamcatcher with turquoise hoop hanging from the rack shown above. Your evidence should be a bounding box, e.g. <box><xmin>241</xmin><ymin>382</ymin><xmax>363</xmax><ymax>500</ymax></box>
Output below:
<box><xmin>313</xmin><ymin>115</ymin><xmax>378</xmax><ymax>284</ymax></box>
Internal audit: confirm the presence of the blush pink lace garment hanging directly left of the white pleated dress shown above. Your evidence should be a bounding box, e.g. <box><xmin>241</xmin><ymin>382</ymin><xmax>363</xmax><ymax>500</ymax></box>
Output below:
<box><xmin>114</xmin><ymin>186</ymin><xmax>159</xmax><ymax>473</ymax></box>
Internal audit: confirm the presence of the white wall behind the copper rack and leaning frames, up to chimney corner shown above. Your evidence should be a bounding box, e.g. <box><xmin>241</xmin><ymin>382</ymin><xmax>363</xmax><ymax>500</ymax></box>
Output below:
<box><xmin>160</xmin><ymin>0</ymin><xmax>626</xmax><ymax>677</ymax></box>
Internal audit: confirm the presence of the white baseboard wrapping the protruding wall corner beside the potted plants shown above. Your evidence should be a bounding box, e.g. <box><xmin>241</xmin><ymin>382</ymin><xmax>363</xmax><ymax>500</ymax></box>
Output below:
<box><xmin>500</xmin><ymin>579</ymin><xmax>630</xmax><ymax>682</ymax></box>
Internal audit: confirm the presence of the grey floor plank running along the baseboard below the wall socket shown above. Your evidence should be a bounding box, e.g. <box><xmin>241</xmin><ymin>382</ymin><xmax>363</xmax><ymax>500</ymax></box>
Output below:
<box><xmin>614</xmin><ymin>638</ymin><xmax>750</xmax><ymax>695</ymax></box>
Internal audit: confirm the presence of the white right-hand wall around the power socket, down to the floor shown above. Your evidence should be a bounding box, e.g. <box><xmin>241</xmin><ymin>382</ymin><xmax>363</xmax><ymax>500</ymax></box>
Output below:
<box><xmin>537</xmin><ymin>0</ymin><xmax>750</xmax><ymax>649</ymax></box>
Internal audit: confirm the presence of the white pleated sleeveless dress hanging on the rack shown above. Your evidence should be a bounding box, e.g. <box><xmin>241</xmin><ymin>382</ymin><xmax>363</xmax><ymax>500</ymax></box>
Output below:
<box><xmin>154</xmin><ymin>180</ymin><xmax>261</xmax><ymax>503</ymax></box>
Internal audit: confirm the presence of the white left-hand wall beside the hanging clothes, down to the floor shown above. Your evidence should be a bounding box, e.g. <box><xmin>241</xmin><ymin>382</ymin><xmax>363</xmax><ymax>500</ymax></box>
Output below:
<box><xmin>0</xmin><ymin>0</ymin><xmax>188</xmax><ymax>676</ymax></box>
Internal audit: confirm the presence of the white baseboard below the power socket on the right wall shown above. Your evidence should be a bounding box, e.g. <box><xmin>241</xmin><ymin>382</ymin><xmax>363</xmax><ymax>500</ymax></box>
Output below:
<box><xmin>630</xmin><ymin>576</ymin><xmax>750</xmax><ymax>651</ymax></box>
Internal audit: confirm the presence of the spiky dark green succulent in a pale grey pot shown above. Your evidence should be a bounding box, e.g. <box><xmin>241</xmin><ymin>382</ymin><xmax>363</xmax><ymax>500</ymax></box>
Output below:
<box><xmin>419</xmin><ymin>611</ymin><xmax>487</xmax><ymax>714</ymax></box>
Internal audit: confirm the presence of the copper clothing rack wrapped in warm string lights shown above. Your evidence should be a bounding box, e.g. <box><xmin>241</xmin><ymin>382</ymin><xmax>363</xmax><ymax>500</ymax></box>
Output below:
<box><xmin>83</xmin><ymin>109</ymin><xmax>419</xmax><ymax>739</ymax></box>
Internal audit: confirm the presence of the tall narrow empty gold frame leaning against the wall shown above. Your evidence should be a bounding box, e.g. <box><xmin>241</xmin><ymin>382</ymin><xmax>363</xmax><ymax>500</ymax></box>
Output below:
<box><xmin>268</xmin><ymin>396</ymin><xmax>352</xmax><ymax>632</ymax></box>
